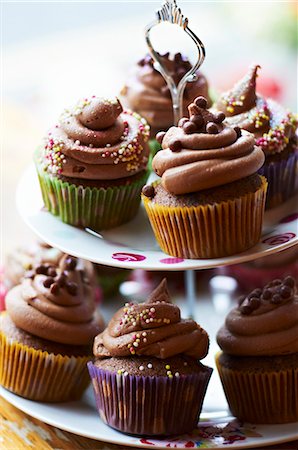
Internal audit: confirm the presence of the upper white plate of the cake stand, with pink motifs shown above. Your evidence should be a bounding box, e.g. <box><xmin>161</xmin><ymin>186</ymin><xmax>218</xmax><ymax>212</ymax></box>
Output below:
<box><xmin>17</xmin><ymin>166</ymin><xmax>298</xmax><ymax>270</ymax></box>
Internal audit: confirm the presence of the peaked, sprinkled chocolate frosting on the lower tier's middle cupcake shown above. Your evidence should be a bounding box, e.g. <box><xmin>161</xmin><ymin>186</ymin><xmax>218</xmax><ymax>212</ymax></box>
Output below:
<box><xmin>93</xmin><ymin>279</ymin><xmax>209</xmax><ymax>360</ymax></box>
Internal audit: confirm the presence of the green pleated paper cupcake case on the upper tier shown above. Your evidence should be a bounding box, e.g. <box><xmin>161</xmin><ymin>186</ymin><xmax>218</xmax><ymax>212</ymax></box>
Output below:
<box><xmin>37</xmin><ymin>165</ymin><xmax>149</xmax><ymax>231</ymax></box>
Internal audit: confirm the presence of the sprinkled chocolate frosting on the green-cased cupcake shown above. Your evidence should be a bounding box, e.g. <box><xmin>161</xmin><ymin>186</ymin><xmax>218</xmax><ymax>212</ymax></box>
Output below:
<box><xmin>41</xmin><ymin>95</ymin><xmax>149</xmax><ymax>180</ymax></box>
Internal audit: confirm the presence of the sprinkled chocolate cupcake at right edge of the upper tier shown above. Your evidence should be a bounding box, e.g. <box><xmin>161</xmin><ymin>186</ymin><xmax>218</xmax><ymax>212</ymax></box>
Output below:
<box><xmin>215</xmin><ymin>65</ymin><xmax>298</xmax><ymax>208</ymax></box>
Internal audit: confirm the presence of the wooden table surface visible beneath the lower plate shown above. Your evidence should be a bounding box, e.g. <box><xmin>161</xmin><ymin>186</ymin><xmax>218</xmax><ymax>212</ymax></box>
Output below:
<box><xmin>0</xmin><ymin>397</ymin><xmax>298</xmax><ymax>450</ymax></box>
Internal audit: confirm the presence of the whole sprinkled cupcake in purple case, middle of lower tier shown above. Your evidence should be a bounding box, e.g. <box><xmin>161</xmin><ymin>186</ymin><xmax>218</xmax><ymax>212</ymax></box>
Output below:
<box><xmin>88</xmin><ymin>280</ymin><xmax>212</xmax><ymax>436</ymax></box>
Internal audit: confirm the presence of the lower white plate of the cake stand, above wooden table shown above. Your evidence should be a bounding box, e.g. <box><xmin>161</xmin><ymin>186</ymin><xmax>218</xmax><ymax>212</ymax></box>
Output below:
<box><xmin>0</xmin><ymin>387</ymin><xmax>298</xmax><ymax>450</ymax></box>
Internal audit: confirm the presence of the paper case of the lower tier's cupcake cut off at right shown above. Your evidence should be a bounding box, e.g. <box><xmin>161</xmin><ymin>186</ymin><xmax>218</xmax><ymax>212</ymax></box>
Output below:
<box><xmin>216</xmin><ymin>353</ymin><xmax>298</xmax><ymax>424</ymax></box>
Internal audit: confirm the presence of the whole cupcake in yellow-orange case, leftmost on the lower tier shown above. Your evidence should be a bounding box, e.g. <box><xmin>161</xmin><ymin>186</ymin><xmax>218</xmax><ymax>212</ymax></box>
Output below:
<box><xmin>0</xmin><ymin>255</ymin><xmax>103</xmax><ymax>402</ymax></box>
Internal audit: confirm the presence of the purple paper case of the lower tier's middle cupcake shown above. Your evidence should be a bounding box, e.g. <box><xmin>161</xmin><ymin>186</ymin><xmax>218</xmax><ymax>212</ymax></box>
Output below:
<box><xmin>88</xmin><ymin>362</ymin><xmax>212</xmax><ymax>436</ymax></box>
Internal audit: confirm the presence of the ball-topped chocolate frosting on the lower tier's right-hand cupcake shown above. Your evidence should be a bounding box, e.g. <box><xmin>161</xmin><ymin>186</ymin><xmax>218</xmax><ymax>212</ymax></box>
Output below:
<box><xmin>217</xmin><ymin>276</ymin><xmax>298</xmax><ymax>356</ymax></box>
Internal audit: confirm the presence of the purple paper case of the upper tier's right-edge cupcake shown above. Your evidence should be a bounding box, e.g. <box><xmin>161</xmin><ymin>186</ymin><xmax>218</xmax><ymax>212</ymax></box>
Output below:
<box><xmin>258</xmin><ymin>151</ymin><xmax>298</xmax><ymax>209</ymax></box>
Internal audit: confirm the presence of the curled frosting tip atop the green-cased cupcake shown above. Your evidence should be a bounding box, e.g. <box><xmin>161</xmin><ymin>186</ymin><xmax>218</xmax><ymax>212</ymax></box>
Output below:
<box><xmin>78</xmin><ymin>97</ymin><xmax>123</xmax><ymax>130</ymax></box>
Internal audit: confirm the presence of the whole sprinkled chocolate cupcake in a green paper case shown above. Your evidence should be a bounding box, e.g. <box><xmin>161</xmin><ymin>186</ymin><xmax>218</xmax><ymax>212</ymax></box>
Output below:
<box><xmin>35</xmin><ymin>96</ymin><xmax>149</xmax><ymax>230</ymax></box>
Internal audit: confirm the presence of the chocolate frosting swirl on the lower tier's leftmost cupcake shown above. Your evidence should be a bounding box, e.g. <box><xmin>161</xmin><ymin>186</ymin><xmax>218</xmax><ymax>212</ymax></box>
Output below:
<box><xmin>5</xmin><ymin>255</ymin><xmax>101</xmax><ymax>345</ymax></box>
